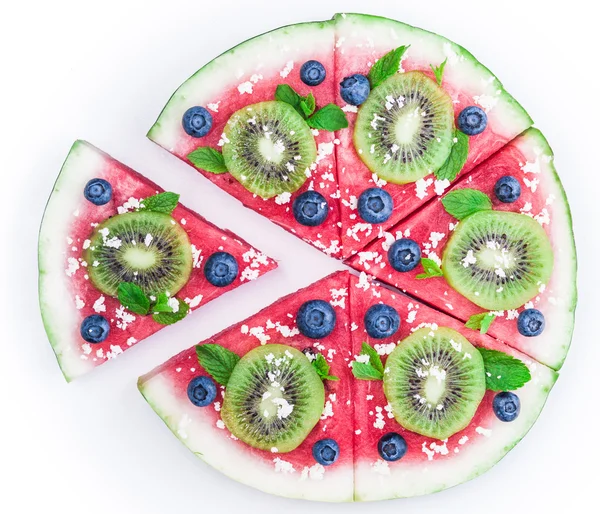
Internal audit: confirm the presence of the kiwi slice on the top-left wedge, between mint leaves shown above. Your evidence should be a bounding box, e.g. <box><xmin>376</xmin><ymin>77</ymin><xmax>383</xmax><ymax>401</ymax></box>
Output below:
<box><xmin>223</xmin><ymin>101</ymin><xmax>317</xmax><ymax>199</ymax></box>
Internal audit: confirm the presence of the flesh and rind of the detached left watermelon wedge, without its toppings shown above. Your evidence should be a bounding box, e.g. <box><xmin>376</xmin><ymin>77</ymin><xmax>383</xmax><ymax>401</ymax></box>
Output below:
<box><xmin>39</xmin><ymin>141</ymin><xmax>277</xmax><ymax>381</ymax></box>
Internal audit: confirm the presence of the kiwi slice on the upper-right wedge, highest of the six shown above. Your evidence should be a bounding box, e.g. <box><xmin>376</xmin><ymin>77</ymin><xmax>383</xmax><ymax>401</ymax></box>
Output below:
<box><xmin>354</xmin><ymin>71</ymin><xmax>454</xmax><ymax>184</ymax></box>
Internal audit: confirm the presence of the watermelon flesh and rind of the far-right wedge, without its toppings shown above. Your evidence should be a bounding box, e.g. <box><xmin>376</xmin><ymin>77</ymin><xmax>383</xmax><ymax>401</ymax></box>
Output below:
<box><xmin>348</xmin><ymin>129</ymin><xmax>577</xmax><ymax>369</ymax></box>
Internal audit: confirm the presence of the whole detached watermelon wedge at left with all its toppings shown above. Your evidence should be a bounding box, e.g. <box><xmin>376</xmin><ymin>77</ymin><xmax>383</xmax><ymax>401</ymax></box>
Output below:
<box><xmin>39</xmin><ymin>141</ymin><xmax>277</xmax><ymax>381</ymax></box>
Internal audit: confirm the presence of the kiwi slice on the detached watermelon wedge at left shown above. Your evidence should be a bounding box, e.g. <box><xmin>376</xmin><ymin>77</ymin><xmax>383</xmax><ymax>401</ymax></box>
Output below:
<box><xmin>84</xmin><ymin>211</ymin><xmax>193</xmax><ymax>296</ymax></box>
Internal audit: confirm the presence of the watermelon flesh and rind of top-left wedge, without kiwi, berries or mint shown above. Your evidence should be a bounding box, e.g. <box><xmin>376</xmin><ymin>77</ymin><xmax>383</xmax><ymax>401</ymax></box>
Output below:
<box><xmin>148</xmin><ymin>22</ymin><xmax>341</xmax><ymax>257</ymax></box>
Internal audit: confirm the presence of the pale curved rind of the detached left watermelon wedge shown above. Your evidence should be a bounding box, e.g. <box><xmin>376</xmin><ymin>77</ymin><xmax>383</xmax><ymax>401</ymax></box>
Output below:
<box><xmin>38</xmin><ymin>141</ymin><xmax>104</xmax><ymax>382</ymax></box>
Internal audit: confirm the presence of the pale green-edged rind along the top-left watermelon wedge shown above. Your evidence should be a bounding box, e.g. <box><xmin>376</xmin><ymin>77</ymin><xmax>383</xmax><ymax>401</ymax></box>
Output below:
<box><xmin>147</xmin><ymin>20</ymin><xmax>333</xmax><ymax>151</ymax></box>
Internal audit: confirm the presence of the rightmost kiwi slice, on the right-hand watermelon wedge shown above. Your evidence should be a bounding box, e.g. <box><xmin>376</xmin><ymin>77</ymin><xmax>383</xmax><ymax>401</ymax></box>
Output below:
<box><xmin>442</xmin><ymin>210</ymin><xmax>554</xmax><ymax>310</ymax></box>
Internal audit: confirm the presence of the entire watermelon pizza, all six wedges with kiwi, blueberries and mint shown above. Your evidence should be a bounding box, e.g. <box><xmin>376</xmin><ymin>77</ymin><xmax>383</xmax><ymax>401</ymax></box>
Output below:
<box><xmin>40</xmin><ymin>14</ymin><xmax>576</xmax><ymax>501</ymax></box>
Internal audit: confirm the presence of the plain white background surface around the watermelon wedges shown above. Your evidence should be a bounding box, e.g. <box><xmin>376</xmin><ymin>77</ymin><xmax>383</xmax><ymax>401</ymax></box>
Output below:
<box><xmin>0</xmin><ymin>0</ymin><xmax>600</xmax><ymax>514</ymax></box>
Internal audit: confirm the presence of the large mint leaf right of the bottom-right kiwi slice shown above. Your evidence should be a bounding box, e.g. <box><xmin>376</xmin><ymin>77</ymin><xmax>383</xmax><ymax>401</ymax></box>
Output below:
<box><xmin>479</xmin><ymin>348</ymin><xmax>531</xmax><ymax>391</ymax></box>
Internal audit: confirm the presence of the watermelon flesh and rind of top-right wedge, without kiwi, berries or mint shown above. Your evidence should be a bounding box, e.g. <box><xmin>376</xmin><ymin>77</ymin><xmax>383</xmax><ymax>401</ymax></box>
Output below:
<box><xmin>335</xmin><ymin>14</ymin><xmax>532</xmax><ymax>258</ymax></box>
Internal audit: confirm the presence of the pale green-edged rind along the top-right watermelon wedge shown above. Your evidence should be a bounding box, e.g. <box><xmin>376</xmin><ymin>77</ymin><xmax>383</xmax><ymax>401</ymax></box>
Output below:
<box><xmin>333</xmin><ymin>13</ymin><xmax>533</xmax><ymax>139</ymax></box>
